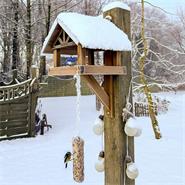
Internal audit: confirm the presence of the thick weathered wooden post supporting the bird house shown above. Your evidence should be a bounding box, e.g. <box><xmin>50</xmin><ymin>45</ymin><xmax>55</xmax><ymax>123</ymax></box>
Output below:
<box><xmin>104</xmin><ymin>5</ymin><xmax>135</xmax><ymax>185</ymax></box>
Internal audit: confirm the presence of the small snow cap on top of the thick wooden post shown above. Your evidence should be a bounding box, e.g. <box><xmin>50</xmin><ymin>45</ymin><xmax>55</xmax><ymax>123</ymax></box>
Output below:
<box><xmin>103</xmin><ymin>1</ymin><xmax>130</xmax><ymax>12</ymax></box>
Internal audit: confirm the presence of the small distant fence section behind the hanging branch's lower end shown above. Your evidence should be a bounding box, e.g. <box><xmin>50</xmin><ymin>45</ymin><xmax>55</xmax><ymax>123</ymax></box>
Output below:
<box><xmin>134</xmin><ymin>102</ymin><xmax>157</xmax><ymax>117</ymax></box>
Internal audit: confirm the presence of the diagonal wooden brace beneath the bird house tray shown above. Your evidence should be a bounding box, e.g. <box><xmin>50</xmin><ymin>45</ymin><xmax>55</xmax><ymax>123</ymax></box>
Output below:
<box><xmin>81</xmin><ymin>75</ymin><xmax>110</xmax><ymax>110</ymax></box>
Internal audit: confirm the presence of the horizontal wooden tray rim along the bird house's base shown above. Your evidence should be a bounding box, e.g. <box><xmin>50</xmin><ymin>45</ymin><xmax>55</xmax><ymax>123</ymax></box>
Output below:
<box><xmin>49</xmin><ymin>65</ymin><xmax>126</xmax><ymax>76</ymax></box>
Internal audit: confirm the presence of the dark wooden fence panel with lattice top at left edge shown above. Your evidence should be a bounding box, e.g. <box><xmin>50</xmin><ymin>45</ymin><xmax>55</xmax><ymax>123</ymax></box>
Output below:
<box><xmin>0</xmin><ymin>79</ymin><xmax>38</xmax><ymax>140</ymax></box>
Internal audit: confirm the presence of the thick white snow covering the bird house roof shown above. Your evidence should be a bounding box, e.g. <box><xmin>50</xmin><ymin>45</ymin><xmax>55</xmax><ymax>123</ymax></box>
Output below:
<box><xmin>42</xmin><ymin>13</ymin><xmax>131</xmax><ymax>53</ymax></box>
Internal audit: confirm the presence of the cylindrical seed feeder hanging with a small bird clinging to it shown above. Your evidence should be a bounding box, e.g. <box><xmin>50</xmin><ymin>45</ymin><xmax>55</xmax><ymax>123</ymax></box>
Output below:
<box><xmin>73</xmin><ymin>136</ymin><xmax>84</xmax><ymax>183</ymax></box>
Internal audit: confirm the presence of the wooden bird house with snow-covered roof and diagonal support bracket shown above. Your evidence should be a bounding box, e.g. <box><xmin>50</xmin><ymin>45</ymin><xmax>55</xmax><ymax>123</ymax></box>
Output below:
<box><xmin>42</xmin><ymin>13</ymin><xmax>131</xmax><ymax>117</ymax></box>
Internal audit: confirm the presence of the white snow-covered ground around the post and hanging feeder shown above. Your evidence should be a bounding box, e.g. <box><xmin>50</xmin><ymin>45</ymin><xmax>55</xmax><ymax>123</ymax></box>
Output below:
<box><xmin>0</xmin><ymin>93</ymin><xmax>185</xmax><ymax>185</ymax></box>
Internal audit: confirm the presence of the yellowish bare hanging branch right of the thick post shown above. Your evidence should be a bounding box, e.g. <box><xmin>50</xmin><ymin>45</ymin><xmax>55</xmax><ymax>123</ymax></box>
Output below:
<box><xmin>139</xmin><ymin>0</ymin><xmax>162</xmax><ymax>139</ymax></box>
